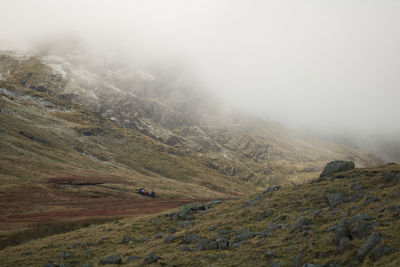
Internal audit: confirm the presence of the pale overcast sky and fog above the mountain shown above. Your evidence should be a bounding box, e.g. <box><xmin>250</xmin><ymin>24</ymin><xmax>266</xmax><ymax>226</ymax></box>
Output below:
<box><xmin>0</xmin><ymin>0</ymin><xmax>400</xmax><ymax>135</ymax></box>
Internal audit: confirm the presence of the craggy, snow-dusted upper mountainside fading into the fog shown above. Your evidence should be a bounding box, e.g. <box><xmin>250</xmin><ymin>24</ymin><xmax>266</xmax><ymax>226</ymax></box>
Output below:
<box><xmin>0</xmin><ymin>53</ymin><xmax>382</xmax><ymax>189</ymax></box>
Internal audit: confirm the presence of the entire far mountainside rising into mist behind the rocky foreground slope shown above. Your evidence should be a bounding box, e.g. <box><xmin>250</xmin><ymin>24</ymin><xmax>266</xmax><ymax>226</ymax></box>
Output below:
<box><xmin>0</xmin><ymin>52</ymin><xmax>381</xmax><ymax>233</ymax></box>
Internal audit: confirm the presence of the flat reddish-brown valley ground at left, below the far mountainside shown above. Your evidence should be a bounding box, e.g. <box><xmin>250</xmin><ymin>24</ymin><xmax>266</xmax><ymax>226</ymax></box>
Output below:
<box><xmin>0</xmin><ymin>178</ymin><xmax>211</xmax><ymax>231</ymax></box>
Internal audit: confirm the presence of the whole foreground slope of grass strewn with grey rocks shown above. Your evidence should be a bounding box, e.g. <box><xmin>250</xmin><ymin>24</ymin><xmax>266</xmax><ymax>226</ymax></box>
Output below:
<box><xmin>0</xmin><ymin>164</ymin><xmax>400</xmax><ymax>267</ymax></box>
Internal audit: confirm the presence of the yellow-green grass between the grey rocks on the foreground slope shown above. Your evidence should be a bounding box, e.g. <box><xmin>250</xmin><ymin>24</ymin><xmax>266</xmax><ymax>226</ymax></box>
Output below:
<box><xmin>0</xmin><ymin>165</ymin><xmax>400</xmax><ymax>266</ymax></box>
